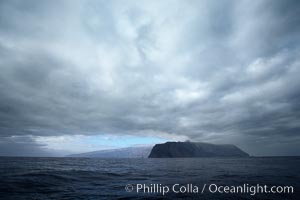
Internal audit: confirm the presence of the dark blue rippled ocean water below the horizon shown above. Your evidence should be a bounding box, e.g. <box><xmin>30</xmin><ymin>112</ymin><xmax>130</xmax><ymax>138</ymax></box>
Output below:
<box><xmin>0</xmin><ymin>157</ymin><xmax>300</xmax><ymax>200</ymax></box>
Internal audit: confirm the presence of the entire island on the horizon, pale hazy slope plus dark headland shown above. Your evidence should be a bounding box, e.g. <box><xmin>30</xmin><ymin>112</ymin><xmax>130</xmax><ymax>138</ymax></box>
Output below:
<box><xmin>67</xmin><ymin>141</ymin><xmax>249</xmax><ymax>158</ymax></box>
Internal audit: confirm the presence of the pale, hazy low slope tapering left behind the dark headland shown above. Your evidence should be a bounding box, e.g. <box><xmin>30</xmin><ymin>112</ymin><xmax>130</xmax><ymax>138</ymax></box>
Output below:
<box><xmin>67</xmin><ymin>146</ymin><xmax>153</xmax><ymax>158</ymax></box>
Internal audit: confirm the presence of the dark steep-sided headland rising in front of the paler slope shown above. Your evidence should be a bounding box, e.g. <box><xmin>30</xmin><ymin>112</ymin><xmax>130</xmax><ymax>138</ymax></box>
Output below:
<box><xmin>149</xmin><ymin>142</ymin><xmax>249</xmax><ymax>158</ymax></box>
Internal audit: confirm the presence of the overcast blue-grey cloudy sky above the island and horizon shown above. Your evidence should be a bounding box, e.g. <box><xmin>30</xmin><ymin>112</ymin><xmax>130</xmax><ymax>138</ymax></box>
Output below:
<box><xmin>0</xmin><ymin>0</ymin><xmax>300</xmax><ymax>156</ymax></box>
